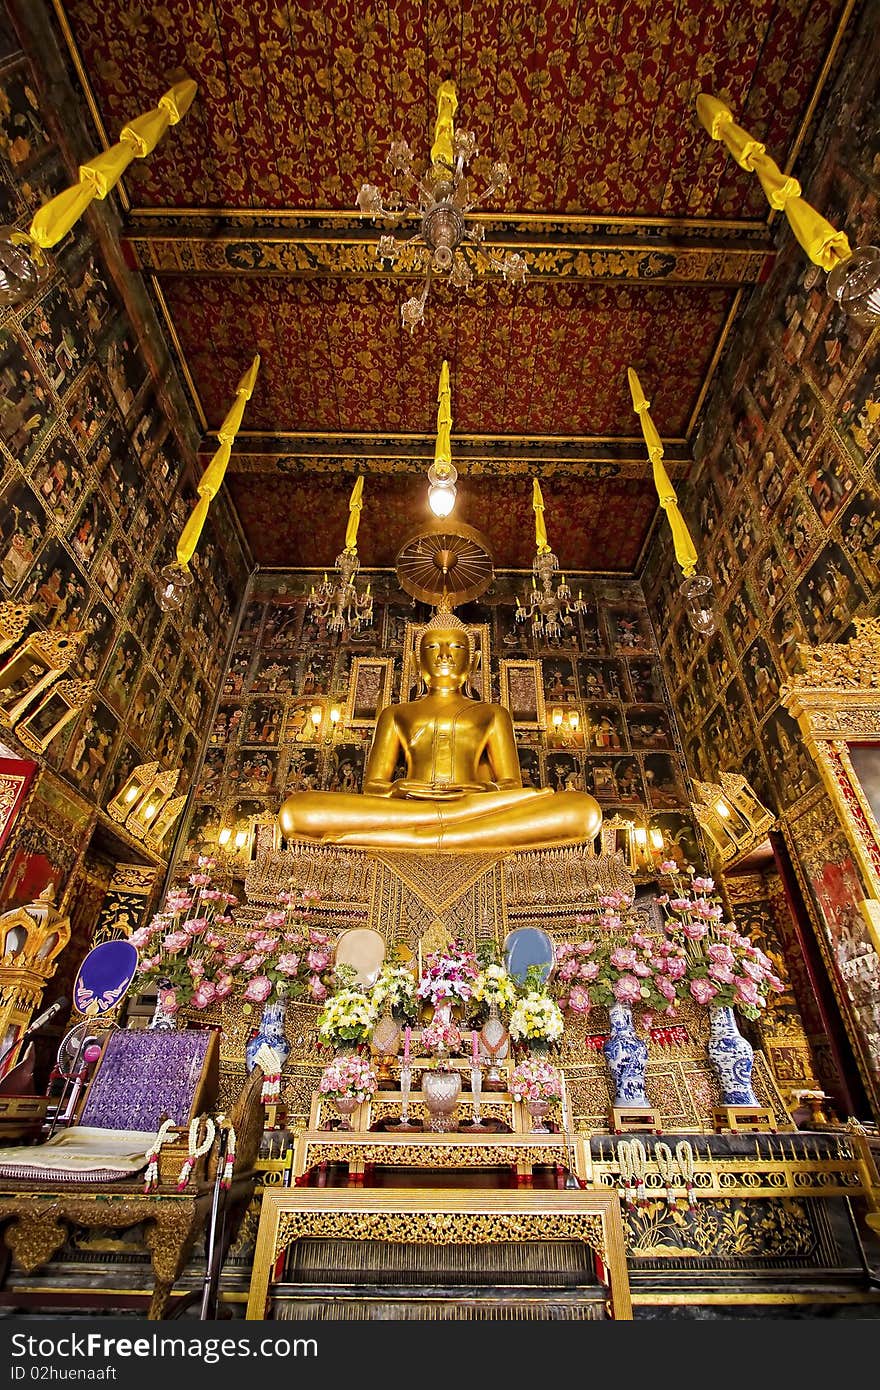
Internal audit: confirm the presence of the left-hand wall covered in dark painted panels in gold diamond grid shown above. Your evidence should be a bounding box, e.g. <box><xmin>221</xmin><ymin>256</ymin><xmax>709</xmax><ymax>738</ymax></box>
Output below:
<box><xmin>0</xmin><ymin>35</ymin><xmax>245</xmax><ymax>906</ymax></box>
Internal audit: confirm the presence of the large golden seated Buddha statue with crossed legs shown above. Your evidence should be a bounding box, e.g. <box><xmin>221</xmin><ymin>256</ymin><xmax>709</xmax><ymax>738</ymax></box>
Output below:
<box><xmin>279</xmin><ymin>609</ymin><xmax>602</xmax><ymax>852</ymax></box>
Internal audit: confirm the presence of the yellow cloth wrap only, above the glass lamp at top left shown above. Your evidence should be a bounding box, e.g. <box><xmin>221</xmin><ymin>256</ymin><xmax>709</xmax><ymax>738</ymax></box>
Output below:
<box><xmin>29</xmin><ymin>78</ymin><xmax>197</xmax><ymax>247</ymax></box>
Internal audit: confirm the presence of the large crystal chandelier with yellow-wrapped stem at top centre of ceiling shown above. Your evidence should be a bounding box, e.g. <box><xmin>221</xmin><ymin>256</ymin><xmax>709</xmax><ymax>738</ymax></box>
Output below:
<box><xmin>357</xmin><ymin>82</ymin><xmax>528</xmax><ymax>334</ymax></box>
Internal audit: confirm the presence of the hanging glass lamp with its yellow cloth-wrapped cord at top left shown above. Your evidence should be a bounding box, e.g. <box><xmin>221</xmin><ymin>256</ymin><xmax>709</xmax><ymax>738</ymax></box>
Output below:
<box><xmin>0</xmin><ymin>78</ymin><xmax>199</xmax><ymax>304</ymax></box>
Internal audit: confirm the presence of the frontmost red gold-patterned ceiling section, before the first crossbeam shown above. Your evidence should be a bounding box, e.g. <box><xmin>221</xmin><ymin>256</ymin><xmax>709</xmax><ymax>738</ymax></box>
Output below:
<box><xmin>61</xmin><ymin>0</ymin><xmax>845</xmax><ymax>218</ymax></box>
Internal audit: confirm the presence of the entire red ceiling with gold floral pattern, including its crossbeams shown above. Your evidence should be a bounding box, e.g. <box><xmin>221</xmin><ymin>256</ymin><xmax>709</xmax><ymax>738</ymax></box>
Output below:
<box><xmin>53</xmin><ymin>0</ymin><xmax>851</xmax><ymax>571</ymax></box>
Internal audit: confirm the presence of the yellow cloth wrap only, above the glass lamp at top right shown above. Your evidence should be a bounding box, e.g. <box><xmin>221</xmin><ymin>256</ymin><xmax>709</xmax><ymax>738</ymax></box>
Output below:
<box><xmin>696</xmin><ymin>92</ymin><xmax>852</xmax><ymax>271</ymax></box>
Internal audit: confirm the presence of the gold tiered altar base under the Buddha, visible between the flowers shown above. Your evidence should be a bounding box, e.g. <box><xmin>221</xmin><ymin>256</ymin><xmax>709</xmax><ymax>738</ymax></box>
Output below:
<box><xmin>222</xmin><ymin>842</ymin><xmax>792</xmax><ymax>1131</ymax></box>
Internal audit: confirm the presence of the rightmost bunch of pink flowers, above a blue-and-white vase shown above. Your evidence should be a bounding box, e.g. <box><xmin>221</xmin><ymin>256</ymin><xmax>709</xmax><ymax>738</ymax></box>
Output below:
<box><xmin>656</xmin><ymin>865</ymin><xmax>784</xmax><ymax>1019</ymax></box>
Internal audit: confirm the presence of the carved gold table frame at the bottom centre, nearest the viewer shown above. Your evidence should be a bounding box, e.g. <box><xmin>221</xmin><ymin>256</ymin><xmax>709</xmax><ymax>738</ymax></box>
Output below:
<box><xmin>247</xmin><ymin>1187</ymin><xmax>633</xmax><ymax>1321</ymax></box>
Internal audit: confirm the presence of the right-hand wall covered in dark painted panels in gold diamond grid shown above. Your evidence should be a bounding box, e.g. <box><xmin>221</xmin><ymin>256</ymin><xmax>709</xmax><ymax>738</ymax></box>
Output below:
<box><xmin>645</xmin><ymin>10</ymin><xmax>880</xmax><ymax>1112</ymax></box>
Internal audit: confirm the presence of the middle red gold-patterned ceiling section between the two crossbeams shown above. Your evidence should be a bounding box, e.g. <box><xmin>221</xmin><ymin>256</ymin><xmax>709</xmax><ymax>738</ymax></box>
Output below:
<box><xmin>164</xmin><ymin>277</ymin><xmax>733</xmax><ymax>436</ymax></box>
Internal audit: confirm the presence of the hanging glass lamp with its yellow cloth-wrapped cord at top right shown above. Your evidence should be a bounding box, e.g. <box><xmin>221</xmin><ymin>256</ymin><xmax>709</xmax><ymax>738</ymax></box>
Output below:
<box><xmin>696</xmin><ymin>92</ymin><xmax>880</xmax><ymax>328</ymax></box>
